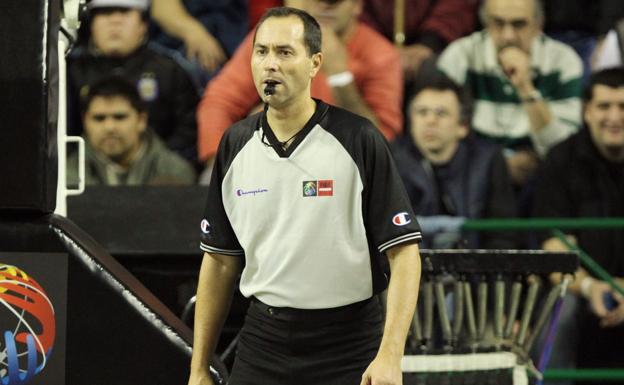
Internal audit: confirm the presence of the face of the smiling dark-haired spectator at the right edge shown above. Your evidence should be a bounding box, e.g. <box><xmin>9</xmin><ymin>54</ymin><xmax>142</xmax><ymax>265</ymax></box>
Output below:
<box><xmin>584</xmin><ymin>84</ymin><xmax>624</xmax><ymax>157</ymax></box>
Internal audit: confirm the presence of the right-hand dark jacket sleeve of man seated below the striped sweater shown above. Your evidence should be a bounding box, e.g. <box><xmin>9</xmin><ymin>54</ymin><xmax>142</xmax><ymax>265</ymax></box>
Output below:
<box><xmin>483</xmin><ymin>151</ymin><xmax>523</xmax><ymax>249</ymax></box>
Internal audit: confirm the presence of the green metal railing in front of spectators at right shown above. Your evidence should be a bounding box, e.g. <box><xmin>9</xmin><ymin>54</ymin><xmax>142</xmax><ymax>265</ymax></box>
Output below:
<box><xmin>462</xmin><ymin>218</ymin><xmax>624</xmax><ymax>381</ymax></box>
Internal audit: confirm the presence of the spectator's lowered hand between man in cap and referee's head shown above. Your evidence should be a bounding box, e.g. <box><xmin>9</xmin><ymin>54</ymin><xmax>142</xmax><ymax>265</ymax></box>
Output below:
<box><xmin>182</xmin><ymin>23</ymin><xmax>226</xmax><ymax>72</ymax></box>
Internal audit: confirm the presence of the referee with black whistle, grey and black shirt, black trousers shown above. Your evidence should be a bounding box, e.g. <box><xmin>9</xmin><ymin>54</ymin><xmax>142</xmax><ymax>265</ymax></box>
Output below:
<box><xmin>189</xmin><ymin>7</ymin><xmax>421</xmax><ymax>385</ymax></box>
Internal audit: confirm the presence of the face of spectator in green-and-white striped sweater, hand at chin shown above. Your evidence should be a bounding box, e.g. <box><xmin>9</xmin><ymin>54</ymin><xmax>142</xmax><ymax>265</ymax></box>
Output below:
<box><xmin>486</xmin><ymin>0</ymin><xmax>541</xmax><ymax>53</ymax></box>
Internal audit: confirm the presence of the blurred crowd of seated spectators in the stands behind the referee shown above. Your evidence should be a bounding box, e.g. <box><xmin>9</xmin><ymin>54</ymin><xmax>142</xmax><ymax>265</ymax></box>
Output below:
<box><xmin>68</xmin><ymin>0</ymin><xmax>624</xmax><ymax>378</ymax></box>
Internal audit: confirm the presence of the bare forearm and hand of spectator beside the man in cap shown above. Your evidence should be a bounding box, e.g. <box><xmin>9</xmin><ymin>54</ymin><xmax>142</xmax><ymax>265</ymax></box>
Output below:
<box><xmin>151</xmin><ymin>0</ymin><xmax>226</xmax><ymax>71</ymax></box>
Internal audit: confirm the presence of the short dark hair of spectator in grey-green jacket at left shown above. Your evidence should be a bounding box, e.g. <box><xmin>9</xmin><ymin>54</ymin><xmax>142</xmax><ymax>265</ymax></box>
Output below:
<box><xmin>80</xmin><ymin>76</ymin><xmax>147</xmax><ymax>115</ymax></box>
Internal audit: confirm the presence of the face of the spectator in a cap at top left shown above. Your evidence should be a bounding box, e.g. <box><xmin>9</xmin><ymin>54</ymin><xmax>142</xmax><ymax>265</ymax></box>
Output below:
<box><xmin>91</xmin><ymin>8</ymin><xmax>147</xmax><ymax>57</ymax></box>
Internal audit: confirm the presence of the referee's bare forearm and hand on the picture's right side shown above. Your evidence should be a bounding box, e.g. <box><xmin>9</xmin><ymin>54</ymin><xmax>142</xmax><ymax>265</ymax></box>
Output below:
<box><xmin>361</xmin><ymin>244</ymin><xmax>421</xmax><ymax>385</ymax></box>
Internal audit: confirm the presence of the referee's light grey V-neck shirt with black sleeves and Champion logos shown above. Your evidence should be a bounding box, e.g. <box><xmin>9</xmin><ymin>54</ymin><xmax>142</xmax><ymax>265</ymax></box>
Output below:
<box><xmin>201</xmin><ymin>100</ymin><xmax>421</xmax><ymax>309</ymax></box>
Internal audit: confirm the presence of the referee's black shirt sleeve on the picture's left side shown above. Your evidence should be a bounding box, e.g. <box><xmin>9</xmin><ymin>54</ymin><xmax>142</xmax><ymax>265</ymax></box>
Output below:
<box><xmin>200</xmin><ymin>133</ymin><xmax>244</xmax><ymax>256</ymax></box>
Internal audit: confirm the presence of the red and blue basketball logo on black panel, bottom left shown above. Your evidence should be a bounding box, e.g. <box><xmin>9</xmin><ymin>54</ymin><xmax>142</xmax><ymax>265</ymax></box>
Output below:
<box><xmin>0</xmin><ymin>264</ymin><xmax>56</xmax><ymax>385</ymax></box>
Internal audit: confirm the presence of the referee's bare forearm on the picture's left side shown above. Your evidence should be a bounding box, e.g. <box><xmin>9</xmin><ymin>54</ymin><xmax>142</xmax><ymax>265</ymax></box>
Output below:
<box><xmin>188</xmin><ymin>253</ymin><xmax>241</xmax><ymax>385</ymax></box>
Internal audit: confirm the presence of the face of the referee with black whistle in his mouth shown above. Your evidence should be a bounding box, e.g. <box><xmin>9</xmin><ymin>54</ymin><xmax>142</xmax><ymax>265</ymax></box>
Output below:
<box><xmin>251</xmin><ymin>16</ymin><xmax>322</xmax><ymax>108</ymax></box>
